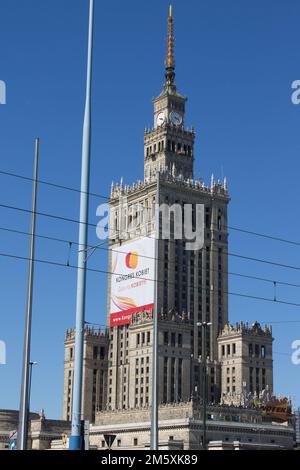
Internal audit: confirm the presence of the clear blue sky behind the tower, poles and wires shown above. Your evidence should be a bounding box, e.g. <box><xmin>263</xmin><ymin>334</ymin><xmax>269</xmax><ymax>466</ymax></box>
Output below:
<box><xmin>0</xmin><ymin>0</ymin><xmax>300</xmax><ymax>418</ymax></box>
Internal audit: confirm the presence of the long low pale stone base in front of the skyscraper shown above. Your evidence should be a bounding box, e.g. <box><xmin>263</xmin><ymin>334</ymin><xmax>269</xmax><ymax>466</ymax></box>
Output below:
<box><xmin>90</xmin><ymin>401</ymin><xmax>295</xmax><ymax>450</ymax></box>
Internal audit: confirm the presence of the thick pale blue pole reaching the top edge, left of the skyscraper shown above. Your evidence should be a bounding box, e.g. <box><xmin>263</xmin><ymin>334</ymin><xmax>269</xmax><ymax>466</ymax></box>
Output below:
<box><xmin>69</xmin><ymin>0</ymin><xmax>94</xmax><ymax>450</ymax></box>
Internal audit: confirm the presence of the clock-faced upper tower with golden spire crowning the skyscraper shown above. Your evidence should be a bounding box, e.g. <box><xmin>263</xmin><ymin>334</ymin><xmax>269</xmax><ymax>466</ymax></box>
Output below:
<box><xmin>144</xmin><ymin>6</ymin><xmax>195</xmax><ymax>181</ymax></box>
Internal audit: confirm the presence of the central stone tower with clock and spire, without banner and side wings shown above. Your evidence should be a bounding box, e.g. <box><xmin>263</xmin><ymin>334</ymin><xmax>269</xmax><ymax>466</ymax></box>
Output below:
<box><xmin>107</xmin><ymin>7</ymin><xmax>229</xmax><ymax>409</ymax></box>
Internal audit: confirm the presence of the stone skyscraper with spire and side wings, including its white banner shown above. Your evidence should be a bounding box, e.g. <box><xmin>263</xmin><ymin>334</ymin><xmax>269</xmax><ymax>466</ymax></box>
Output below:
<box><xmin>64</xmin><ymin>8</ymin><xmax>273</xmax><ymax>442</ymax></box>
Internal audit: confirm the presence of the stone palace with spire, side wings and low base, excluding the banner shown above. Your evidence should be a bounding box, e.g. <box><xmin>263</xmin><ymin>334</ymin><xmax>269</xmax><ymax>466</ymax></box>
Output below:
<box><xmin>58</xmin><ymin>8</ymin><xmax>289</xmax><ymax>449</ymax></box>
